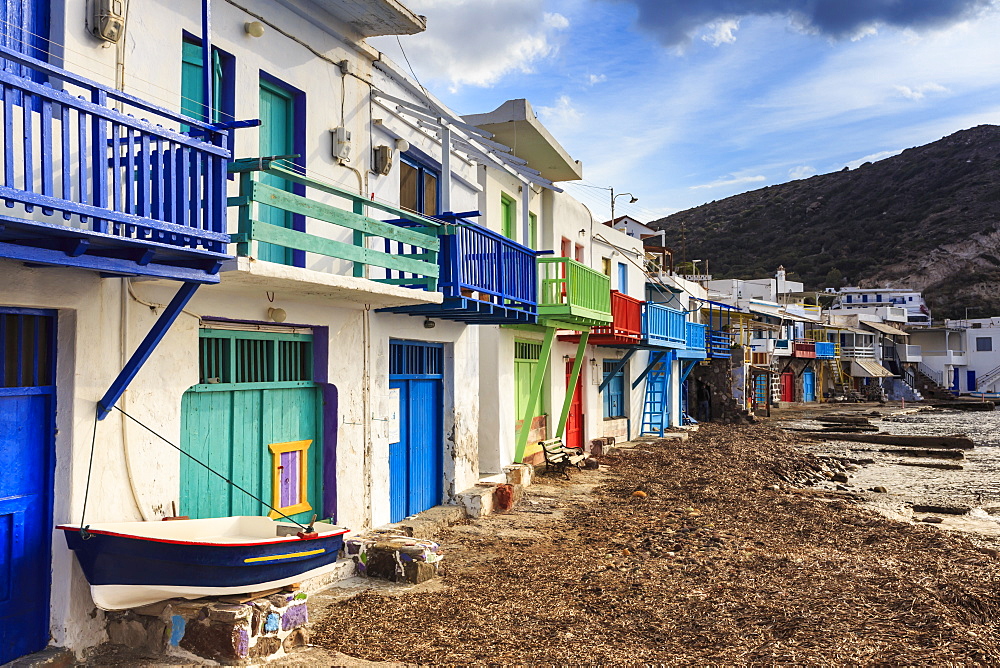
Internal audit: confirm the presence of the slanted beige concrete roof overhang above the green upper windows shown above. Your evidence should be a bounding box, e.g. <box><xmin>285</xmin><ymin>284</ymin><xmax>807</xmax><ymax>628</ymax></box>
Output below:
<box><xmin>463</xmin><ymin>98</ymin><xmax>583</xmax><ymax>181</ymax></box>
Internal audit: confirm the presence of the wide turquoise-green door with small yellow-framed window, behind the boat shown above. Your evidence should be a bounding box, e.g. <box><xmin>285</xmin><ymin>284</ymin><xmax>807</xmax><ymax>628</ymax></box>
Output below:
<box><xmin>178</xmin><ymin>329</ymin><xmax>323</xmax><ymax>522</ymax></box>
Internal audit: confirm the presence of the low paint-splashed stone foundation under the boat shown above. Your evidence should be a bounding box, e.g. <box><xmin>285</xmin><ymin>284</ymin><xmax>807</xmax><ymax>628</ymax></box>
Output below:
<box><xmin>107</xmin><ymin>589</ymin><xmax>309</xmax><ymax>665</ymax></box>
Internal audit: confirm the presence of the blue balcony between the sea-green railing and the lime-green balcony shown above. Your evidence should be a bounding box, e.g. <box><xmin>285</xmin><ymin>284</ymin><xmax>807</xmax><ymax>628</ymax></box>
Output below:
<box><xmin>385</xmin><ymin>213</ymin><xmax>538</xmax><ymax>325</ymax></box>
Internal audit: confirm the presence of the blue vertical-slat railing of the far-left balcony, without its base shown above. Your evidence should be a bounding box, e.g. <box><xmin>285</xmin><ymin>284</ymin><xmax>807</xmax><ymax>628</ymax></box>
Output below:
<box><xmin>0</xmin><ymin>46</ymin><xmax>230</xmax><ymax>253</ymax></box>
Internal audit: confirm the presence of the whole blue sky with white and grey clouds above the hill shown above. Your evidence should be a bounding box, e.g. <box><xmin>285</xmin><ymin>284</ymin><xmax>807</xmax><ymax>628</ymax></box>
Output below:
<box><xmin>370</xmin><ymin>0</ymin><xmax>1000</xmax><ymax>221</ymax></box>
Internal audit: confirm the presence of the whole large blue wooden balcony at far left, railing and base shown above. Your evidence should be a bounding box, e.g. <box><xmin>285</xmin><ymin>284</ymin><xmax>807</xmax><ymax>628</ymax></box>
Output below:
<box><xmin>0</xmin><ymin>41</ymin><xmax>230</xmax><ymax>283</ymax></box>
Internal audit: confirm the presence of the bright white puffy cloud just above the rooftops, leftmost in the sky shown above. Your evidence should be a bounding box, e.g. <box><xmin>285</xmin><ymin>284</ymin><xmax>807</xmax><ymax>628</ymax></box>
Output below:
<box><xmin>369</xmin><ymin>0</ymin><xmax>570</xmax><ymax>92</ymax></box>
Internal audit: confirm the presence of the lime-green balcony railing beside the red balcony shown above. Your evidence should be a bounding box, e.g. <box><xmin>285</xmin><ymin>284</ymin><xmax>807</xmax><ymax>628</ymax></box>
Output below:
<box><xmin>538</xmin><ymin>257</ymin><xmax>612</xmax><ymax>327</ymax></box>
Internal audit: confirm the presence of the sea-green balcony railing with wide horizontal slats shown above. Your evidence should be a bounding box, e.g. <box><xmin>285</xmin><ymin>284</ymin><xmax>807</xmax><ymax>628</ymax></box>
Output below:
<box><xmin>229</xmin><ymin>158</ymin><xmax>448</xmax><ymax>292</ymax></box>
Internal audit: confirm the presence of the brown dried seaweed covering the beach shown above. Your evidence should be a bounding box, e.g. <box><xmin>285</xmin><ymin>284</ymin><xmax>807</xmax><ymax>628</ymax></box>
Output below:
<box><xmin>313</xmin><ymin>425</ymin><xmax>1000</xmax><ymax>666</ymax></box>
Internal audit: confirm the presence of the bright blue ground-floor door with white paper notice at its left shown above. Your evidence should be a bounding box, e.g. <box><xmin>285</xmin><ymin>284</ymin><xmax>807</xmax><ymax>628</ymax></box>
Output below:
<box><xmin>389</xmin><ymin>341</ymin><xmax>444</xmax><ymax>522</ymax></box>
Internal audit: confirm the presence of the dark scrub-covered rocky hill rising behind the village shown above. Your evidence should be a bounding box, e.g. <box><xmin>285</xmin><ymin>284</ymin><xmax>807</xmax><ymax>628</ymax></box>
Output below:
<box><xmin>651</xmin><ymin>125</ymin><xmax>1000</xmax><ymax>319</ymax></box>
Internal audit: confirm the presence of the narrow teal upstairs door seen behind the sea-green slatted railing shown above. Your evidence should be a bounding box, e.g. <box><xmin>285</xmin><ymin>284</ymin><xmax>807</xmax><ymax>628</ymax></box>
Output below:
<box><xmin>257</xmin><ymin>81</ymin><xmax>297</xmax><ymax>264</ymax></box>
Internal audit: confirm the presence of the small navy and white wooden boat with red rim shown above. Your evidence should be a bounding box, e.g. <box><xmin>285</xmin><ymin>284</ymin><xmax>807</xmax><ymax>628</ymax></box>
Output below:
<box><xmin>57</xmin><ymin>517</ymin><xmax>348</xmax><ymax>610</ymax></box>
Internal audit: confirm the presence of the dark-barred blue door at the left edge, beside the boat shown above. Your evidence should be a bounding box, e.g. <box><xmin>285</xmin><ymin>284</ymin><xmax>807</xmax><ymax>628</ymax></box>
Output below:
<box><xmin>0</xmin><ymin>309</ymin><xmax>55</xmax><ymax>664</ymax></box>
